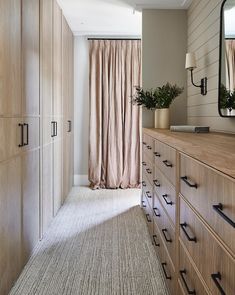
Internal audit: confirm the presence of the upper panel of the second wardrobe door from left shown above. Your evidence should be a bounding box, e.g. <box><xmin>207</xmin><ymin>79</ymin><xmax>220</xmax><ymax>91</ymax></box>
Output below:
<box><xmin>22</xmin><ymin>0</ymin><xmax>40</xmax><ymax>116</ymax></box>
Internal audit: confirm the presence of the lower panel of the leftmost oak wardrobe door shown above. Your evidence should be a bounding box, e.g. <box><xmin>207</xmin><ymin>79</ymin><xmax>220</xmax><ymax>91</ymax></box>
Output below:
<box><xmin>0</xmin><ymin>157</ymin><xmax>22</xmax><ymax>295</ymax></box>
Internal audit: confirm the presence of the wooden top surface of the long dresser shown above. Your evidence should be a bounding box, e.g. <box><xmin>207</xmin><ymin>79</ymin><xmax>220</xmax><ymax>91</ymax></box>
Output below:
<box><xmin>143</xmin><ymin>128</ymin><xmax>235</xmax><ymax>178</ymax></box>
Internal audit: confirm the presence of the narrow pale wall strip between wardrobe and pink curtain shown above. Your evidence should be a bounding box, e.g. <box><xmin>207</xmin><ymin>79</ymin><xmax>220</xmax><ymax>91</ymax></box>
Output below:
<box><xmin>74</xmin><ymin>36</ymin><xmax>89</xmax><ymax>185</ymax></box>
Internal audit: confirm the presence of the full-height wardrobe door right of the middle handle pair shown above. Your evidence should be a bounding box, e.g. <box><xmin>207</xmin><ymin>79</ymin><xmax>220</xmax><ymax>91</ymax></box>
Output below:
<box><xmin>53</xmin><ymin>0</ymin><xmax>63</xmax><ymax>216</ymax></box>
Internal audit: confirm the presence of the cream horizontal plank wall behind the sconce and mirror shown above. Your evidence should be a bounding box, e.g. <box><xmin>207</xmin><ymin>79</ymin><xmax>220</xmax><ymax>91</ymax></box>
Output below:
<box><xmin>188</xmin><ymin>0</ymin><xmax>235</xmax><ymax>133</ymax></box>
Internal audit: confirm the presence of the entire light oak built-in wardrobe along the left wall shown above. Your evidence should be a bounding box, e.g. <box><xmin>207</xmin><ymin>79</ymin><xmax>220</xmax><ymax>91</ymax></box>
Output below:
<box><xmin>0</xmin><ymin>0</ymin><xmax>73</xmax><ymax>295</ymax></box>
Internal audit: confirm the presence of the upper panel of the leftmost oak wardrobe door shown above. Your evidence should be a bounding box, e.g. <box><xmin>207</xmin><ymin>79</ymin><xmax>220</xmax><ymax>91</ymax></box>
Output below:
<box><xmin>0</xmin><ymin>0</ymin><xmax>21</xmax><ymax>117</ymax></box>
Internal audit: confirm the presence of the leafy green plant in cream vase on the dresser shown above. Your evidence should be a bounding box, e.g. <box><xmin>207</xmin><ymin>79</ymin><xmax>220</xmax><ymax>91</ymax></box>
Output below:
<box><xmin>132</xmin><ymin>83</ymin><xmax>184</xmax><ymax>129</ymax></box>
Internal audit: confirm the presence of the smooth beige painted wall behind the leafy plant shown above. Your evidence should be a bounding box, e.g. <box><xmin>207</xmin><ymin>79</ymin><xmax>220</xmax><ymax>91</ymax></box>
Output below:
<box><xmin>142</xmin><ymin>9</ymin><xmax>187</xmax><ymax>127</ymax></box>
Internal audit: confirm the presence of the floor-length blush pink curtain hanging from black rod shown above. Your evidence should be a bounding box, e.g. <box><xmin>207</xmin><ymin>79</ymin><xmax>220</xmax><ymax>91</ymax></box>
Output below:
<box><xmin>89</xmin><ymin>40</ymin><xmax>141</xmax><ymax>189</ymax></box>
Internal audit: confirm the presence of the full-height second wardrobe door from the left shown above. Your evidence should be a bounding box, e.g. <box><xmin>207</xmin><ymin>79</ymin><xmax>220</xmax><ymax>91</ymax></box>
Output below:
<box><xmin>22</xmin><ymin>0</ymin><xmax>40</xmax><ymax>262</ymax></box>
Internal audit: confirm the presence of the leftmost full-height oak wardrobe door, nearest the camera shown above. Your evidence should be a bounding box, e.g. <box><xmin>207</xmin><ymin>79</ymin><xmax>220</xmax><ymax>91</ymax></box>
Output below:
<box><xmin>0</xmin><ymin>0</ymin><xmax>22</xmax><ymax>295</ymax></box>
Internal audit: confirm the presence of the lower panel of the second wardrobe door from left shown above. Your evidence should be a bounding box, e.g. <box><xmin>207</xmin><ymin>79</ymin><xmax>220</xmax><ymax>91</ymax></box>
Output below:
<box><xmin>22</xmin><ymin>149</ymin><xmax>40</xmax><ymax>262</ymax></box>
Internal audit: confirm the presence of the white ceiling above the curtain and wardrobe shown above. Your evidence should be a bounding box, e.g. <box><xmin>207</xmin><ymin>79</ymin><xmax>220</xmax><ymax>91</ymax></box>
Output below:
<box><xmin>57</xmin><ymin>0</ymin><xmax>191</xmax><ymax>36</ymax></box>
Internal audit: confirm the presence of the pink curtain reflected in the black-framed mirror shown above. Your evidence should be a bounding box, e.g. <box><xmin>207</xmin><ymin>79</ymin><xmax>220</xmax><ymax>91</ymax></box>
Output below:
<box><xmin>225</xmin><ymin>40</ymin><xmax>235</xmax><ymax>91</ymax></box>
